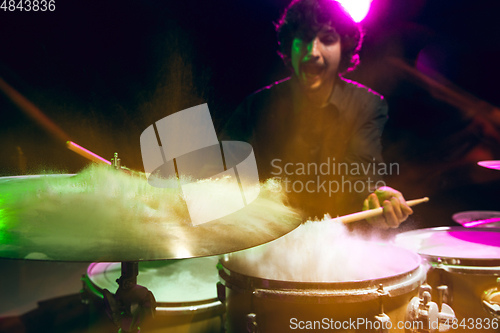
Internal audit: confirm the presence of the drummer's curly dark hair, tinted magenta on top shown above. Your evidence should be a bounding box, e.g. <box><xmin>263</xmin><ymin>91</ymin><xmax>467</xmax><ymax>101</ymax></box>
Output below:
<box><xmin>276</xmin><ymin>0</ymin><xmax>363</xmax><ymax>74</ymax></box>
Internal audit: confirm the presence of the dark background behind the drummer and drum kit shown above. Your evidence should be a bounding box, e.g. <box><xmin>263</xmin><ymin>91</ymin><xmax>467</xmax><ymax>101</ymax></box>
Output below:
<box><xmin>0</xmin><ymin>0</ymin><xmax>500</xmax><ymax>228</ymax></box>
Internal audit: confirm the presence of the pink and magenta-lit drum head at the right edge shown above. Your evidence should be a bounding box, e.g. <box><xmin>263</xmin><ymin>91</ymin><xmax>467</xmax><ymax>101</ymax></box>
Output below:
<box><xmin>395</xmin><ymin>227</ymin><xmax>500</xmax><ymax>266</ymax></box>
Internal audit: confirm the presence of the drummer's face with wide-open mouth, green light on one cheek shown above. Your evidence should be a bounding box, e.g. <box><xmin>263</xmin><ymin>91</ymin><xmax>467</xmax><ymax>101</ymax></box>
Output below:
<box><xmin>291</xmin><ymin>27</ymin><xmax>341</xmax><ymax>91</ymax></box>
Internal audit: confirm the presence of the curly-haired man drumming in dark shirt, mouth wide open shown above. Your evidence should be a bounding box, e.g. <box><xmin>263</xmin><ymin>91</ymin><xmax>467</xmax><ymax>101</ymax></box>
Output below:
<box><xmin>224</xmin><ymin>0</ymin><xmax>412</xmax><ymax>229</ymax></box>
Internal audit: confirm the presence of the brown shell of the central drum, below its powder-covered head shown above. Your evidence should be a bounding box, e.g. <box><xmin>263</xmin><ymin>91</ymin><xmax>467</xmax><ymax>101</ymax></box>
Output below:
<box><xmin>219</xmin><ymin>255</ymin><xmax>426</xmax><ymax>333</ymax></box>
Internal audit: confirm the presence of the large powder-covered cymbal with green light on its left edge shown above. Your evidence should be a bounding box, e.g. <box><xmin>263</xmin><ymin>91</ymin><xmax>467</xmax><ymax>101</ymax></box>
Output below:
<box><xmin>0</xmin><ymin>171</ymin><xmax>301</xmax><ymax>262</ymax></box>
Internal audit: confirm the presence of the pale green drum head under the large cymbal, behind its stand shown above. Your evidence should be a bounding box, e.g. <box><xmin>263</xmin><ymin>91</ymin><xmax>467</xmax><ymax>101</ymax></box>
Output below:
<box><xmin>87</xmin><ymin>257</ymin><xmax>218</xmax><ymax>303</ymax></box>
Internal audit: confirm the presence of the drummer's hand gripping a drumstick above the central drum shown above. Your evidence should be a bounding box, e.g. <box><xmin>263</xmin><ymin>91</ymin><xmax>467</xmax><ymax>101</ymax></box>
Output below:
<box><xmin>363</xmin><ymin>186</ymin><xmax>413</xmax><ymax>229</ymax></box>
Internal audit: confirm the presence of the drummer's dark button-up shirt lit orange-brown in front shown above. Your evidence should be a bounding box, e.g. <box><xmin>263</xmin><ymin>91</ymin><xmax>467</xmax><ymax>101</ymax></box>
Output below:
<box><xmin>223</xmin><ymin>78</ymin><xmax>387</xmax><ymax>218</ymax></box>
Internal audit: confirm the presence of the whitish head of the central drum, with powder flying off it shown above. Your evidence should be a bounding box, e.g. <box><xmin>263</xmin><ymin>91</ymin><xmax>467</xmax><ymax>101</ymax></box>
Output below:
<box><xmin>222</xmin><ymin>240</ymin><xmax>421</xmax><ymax>283</ymax></box>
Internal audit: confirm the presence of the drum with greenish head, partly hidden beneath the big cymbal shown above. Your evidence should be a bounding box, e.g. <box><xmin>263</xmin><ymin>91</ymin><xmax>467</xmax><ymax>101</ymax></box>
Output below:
<box><xmin>84</xmin><ymin>257</ymin><xmax>225</xmax><ymax>333</ymax></box>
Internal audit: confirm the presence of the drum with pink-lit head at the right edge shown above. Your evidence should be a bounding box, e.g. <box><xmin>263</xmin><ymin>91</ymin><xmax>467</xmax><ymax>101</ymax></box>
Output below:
<box><xmin>396</xmin><ymin>227</ymin><xmax>500</xmax><ymax>332</ymax></box>
